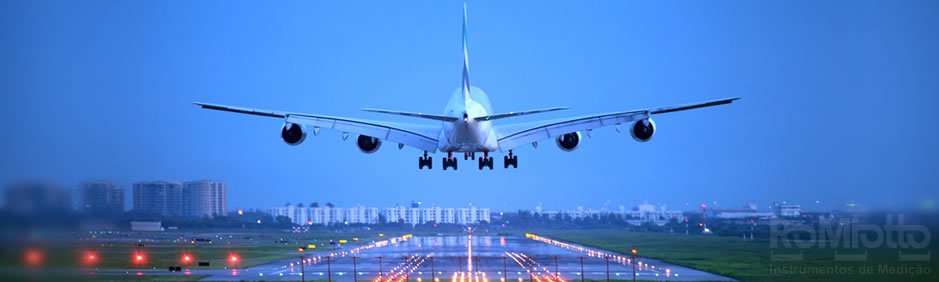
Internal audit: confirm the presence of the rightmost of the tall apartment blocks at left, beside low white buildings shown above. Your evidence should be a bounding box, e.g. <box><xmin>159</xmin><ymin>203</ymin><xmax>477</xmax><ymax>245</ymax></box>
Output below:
<box><xmin>182</xmin><ymin>180</ymin><xmax>228</xmax><ymax>217</ymax></box>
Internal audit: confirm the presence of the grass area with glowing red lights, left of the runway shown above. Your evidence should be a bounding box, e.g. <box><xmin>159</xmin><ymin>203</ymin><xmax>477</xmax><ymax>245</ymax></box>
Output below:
<box><xmin>0</xmin><ymin>229</ymin><xmax>402</xmax><ymax>269</ymax></box>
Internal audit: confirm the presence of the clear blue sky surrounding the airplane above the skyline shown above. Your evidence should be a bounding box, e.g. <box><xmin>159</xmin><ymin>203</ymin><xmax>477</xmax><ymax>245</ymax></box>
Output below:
<box><xmin>0</xmin><ymin>0</ymin><xmax>939</xmax><ymax>210</ymax></box>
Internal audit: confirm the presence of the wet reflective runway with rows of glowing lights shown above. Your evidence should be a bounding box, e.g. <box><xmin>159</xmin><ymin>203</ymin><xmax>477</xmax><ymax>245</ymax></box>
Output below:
<box><xmin>192</xmin><ymin>236</ymin><xmax>733</xmax><ymax>282</ymax></box>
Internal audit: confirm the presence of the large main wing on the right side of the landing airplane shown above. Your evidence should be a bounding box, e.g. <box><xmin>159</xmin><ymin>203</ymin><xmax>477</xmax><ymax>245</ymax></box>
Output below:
<box><xmin>497</xmin><ymin>97</ymin><xmax>740</xmax><ymax>151</ymax></box>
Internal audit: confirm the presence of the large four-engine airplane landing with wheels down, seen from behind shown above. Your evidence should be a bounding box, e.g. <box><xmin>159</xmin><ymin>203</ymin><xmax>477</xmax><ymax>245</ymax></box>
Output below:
<box><xmin>193</xmin><ymin>3</ymin><xmax>740</xmax><ymax>170</ymax></box>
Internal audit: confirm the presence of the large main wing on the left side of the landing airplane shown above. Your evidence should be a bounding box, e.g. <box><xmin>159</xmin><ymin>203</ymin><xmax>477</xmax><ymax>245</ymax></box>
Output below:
<box><xmin>193</xmin><ymin>102</ymin><xmax>441</xmax><ymax>152</ymax></box>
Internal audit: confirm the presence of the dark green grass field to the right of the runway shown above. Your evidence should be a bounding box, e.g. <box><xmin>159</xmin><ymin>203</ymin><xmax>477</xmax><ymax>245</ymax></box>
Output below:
<box><xmin>533</xmin><ymin>230</ymin><xmax>939</xmax><ymax>281</ymax></box>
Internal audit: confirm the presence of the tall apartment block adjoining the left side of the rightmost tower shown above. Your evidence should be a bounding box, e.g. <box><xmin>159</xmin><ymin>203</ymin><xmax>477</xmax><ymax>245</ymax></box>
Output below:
<box><xmin>134</xmin><ymin>181</ymin><xmax>183</xmax><ymax>216</ymax></box>
